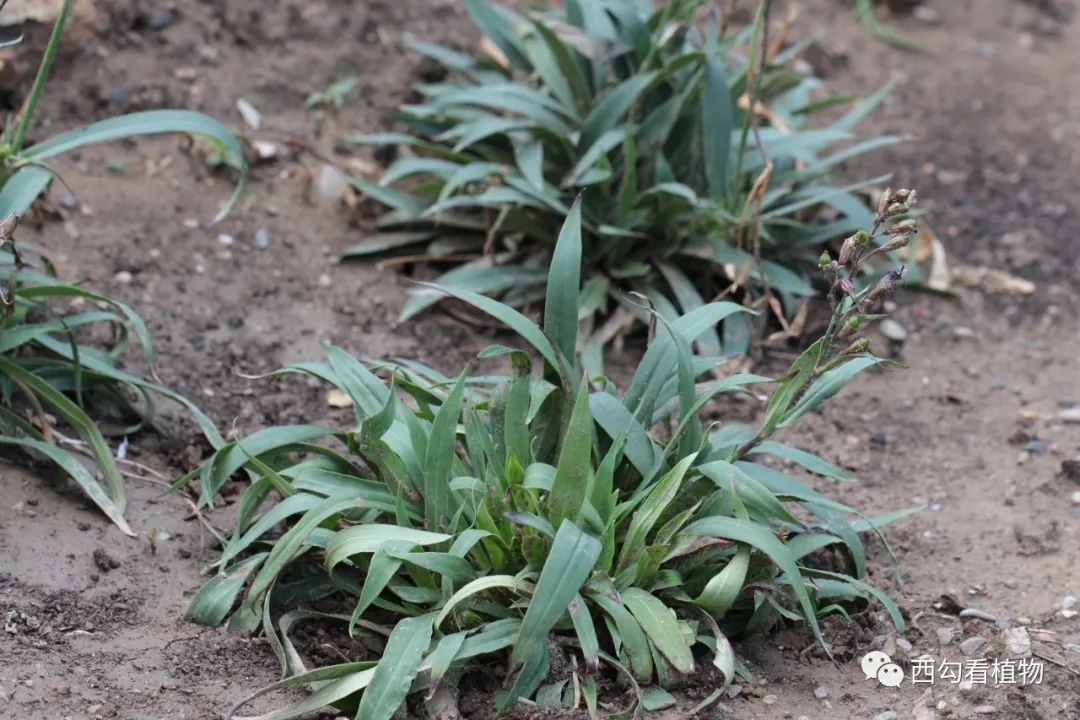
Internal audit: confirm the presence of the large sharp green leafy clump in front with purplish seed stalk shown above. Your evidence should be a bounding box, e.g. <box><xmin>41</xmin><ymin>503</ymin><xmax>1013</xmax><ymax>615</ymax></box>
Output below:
<box><xmin>188</xmin><ymin>191</ymin><xmax>914</xmax><ymax>720</ymax></box>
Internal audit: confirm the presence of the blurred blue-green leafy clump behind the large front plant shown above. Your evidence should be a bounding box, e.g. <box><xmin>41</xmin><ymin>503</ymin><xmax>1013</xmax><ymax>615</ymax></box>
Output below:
<box><xmin>349</xmin><ymin>0</ymin><xmax>897</xmax><ymax>354</ymax></box>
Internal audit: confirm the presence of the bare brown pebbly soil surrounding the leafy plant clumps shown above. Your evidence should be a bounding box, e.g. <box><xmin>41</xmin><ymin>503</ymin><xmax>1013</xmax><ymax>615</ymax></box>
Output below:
<box><xmin>0</xmin><ymin>0</ymin><xmax>1080</xmax><ymax>720</ymax></box>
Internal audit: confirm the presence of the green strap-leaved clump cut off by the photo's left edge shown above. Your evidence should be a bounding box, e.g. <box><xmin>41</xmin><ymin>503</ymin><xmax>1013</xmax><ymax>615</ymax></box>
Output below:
<box><xmin>0</xmin><ymin>1</ymin><xmax>243</xmax><ymax>534</ymax></box>
